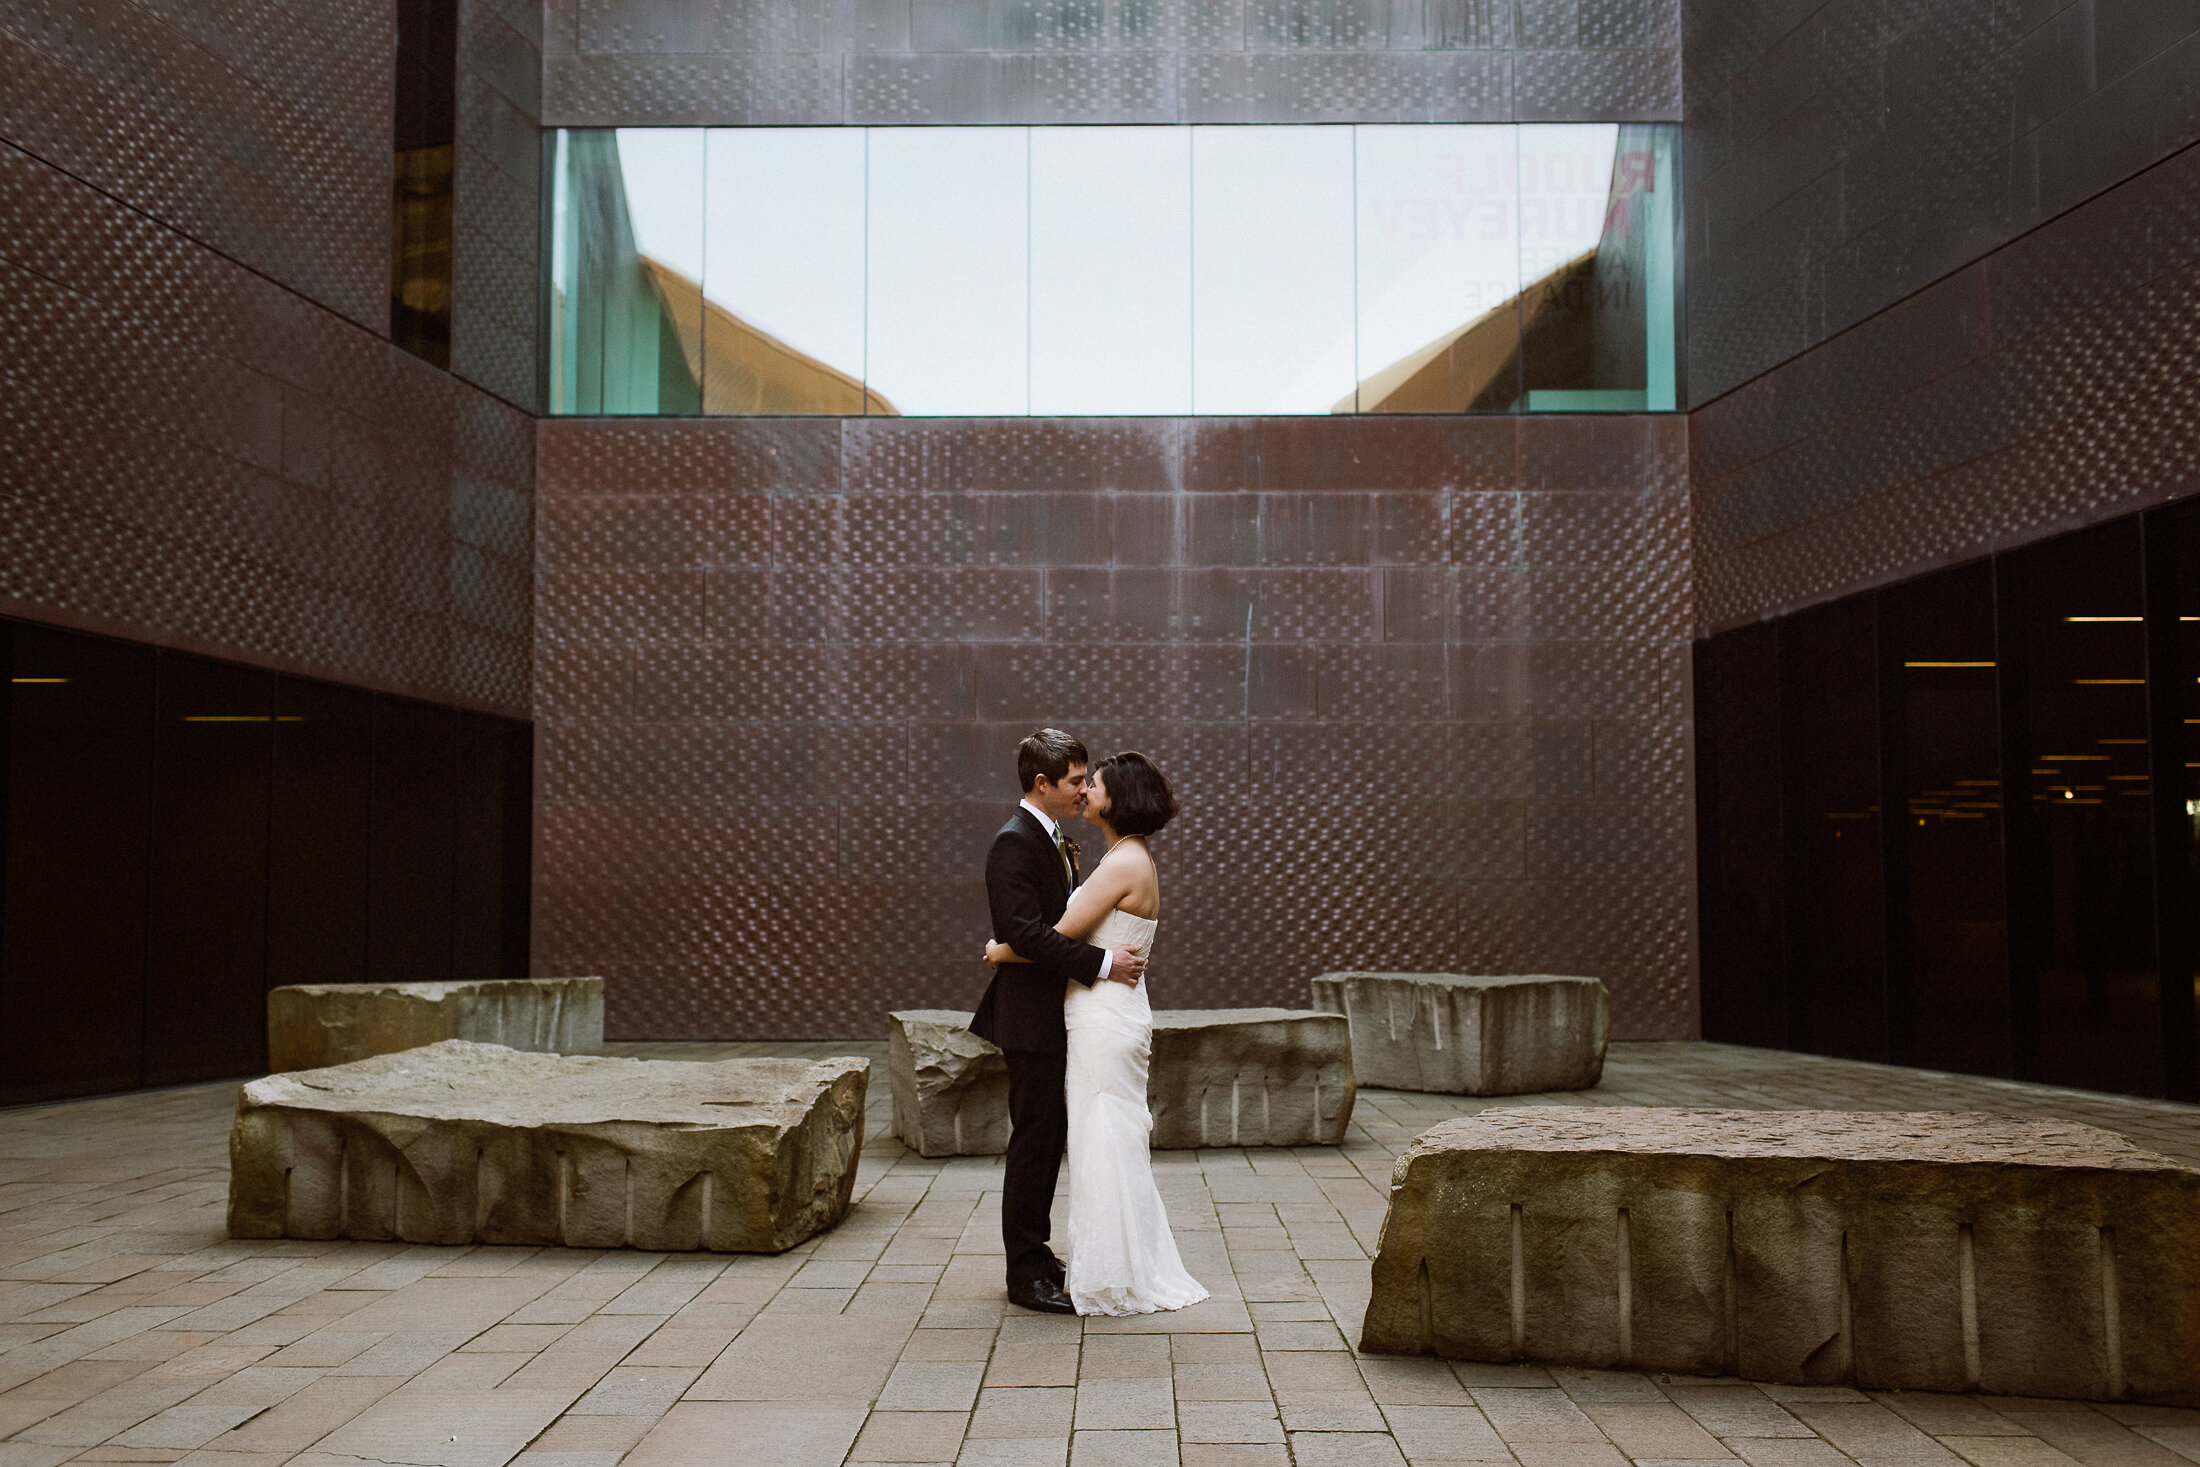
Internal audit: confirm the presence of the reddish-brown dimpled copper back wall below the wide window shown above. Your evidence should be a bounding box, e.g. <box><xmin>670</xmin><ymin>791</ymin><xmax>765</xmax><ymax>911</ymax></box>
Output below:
<box><xmin>535</xmin><ymin>416</ymin><xmax>1696</xmax><ymax>1038</ymax></box>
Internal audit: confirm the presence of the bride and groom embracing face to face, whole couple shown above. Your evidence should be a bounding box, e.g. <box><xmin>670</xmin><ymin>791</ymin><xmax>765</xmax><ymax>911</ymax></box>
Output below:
<box><xmin>970</xmin><ymin>728</ymin><xmax>1208</xmax><ymax>1315</ymax></box>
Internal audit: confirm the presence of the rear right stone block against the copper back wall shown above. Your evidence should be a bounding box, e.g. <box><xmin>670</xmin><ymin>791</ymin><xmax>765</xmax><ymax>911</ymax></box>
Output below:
<box><xmin>1313</xmin><ymin>972</ymin><xmax>1613</xmax><ymax>1095</ymax></box>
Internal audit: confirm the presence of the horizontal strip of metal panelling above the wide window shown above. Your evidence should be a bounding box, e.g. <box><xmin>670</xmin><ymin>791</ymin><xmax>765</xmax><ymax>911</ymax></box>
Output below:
<box><xmin>543</xmin><ymin>0</ymin><xmax>1681</xmax><ymax>128</ymax></box>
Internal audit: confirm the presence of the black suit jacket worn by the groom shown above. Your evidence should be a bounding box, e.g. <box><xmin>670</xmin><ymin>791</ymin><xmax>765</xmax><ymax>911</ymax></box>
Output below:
<box><xmin>970</xmin><ymin>805</ymin><xmax>1104</xmax><ymax>1049</ymax></box>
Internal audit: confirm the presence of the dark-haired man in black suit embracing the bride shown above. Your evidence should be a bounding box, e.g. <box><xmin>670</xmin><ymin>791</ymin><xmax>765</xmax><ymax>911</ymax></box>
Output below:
<box><xmin>970</xmin><ymin>728</ymin><xmax>1146</xmax><ymax>1315</ymax></box>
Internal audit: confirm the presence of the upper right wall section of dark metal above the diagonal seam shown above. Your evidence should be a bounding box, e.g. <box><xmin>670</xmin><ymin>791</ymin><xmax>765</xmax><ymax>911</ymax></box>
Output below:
<box><xmin>1680</xmin><ymin>0</ymin><xmax>2200</xmax><ymax>402</ymax></box>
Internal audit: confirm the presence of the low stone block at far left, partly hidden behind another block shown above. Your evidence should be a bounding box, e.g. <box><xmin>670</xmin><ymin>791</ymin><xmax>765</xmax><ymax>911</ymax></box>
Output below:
<box><xmin>268</xmin><ymin>979</ymin><xmax>603</xmax><ymax>1071</ymax></box>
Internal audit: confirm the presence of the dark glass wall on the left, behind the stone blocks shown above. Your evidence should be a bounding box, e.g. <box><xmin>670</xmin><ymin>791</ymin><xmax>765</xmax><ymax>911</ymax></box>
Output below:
<box><xmin>0</xmin><ymin>620</ymin><xmax>532</xmax><ymax>1104</ymax></box>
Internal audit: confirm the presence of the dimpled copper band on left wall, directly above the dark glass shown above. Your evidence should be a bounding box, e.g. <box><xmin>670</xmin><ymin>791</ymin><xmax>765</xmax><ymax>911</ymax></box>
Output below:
<box><xmin>0</xmin><ymin>147</ymin><xmax>535</xmax><ymax>715</ymax></box>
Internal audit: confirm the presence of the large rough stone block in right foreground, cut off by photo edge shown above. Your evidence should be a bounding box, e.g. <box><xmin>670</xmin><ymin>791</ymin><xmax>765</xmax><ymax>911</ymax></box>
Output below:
<box><xmin>1360</xmin><ymin>1106</ymin><xmax>2200</xmax><ymax>1403</ymax></box>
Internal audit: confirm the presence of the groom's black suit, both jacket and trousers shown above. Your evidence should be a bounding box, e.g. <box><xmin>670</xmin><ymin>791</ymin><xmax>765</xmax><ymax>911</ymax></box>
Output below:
<box><xmin>970</xmin><ymin>805</ymin><xmax>1104</xmax><ymax>1291</ymax></box>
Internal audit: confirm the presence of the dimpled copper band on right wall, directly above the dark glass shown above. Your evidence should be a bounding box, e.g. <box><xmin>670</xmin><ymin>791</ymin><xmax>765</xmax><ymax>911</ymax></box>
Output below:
<box><xmin>1690</xmin><ymin>137</ymin><xmax>2200</xmax><ymax>631</ymax></box>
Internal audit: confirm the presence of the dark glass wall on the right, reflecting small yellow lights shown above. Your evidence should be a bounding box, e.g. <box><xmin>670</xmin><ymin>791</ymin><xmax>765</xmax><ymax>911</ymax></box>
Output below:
<box><xmin>1696</xmin><ymin>504</ymin><xmax>2200</xmax><ymax>1100</ymax></box>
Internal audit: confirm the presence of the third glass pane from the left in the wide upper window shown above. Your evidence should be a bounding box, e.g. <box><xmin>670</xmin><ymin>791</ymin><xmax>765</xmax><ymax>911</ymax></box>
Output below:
<box><xmin>867</xmin><ymin>128</ymin><xmax>1032</xmax><ymax>413</ymax></box>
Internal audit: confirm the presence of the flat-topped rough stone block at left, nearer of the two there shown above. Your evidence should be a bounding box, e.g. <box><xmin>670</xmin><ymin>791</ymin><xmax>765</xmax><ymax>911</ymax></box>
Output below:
<box><xmin>229</xmin><ymin>1040</ymin><xmax>869</xmax><ymax>1254</ymax></box>
